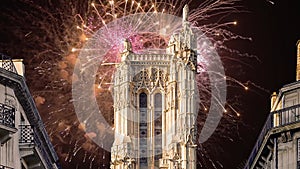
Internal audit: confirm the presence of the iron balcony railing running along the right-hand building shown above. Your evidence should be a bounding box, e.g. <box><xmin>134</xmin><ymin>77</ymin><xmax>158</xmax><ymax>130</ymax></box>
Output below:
<box><xmin>244</xmin><ymin>104</ymin><xmax>300</xmax><ymax>169</ymax></box>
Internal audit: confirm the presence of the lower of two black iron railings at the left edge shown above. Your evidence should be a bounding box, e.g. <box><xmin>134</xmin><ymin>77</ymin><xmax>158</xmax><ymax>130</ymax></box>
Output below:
<box><xmin>0</xmin><ymin>103</ymin><xmax>15</xmax><ymax>128</ymax></box>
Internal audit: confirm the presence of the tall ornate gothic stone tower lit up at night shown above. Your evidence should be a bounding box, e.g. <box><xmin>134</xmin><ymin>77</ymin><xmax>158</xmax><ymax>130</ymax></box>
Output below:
<box><xmin>111</xmin><ymin>6</ymin><xmax>198</xmax><ymax>169</ymax></box>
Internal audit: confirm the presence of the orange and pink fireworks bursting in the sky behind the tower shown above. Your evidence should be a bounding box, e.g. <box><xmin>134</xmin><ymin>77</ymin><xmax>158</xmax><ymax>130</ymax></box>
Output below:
<box><xmin>0</xmin><ymin>0</ymin><xmax>250</xmax><ymax>168</ymax></box>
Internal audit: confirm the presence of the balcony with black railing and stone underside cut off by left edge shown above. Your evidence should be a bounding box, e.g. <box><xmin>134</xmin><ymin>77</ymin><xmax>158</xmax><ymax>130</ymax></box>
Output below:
<box><xmin>0</xmin><ymin>103</ymin><xmax>17</xmax><ymax>143</ymax></box>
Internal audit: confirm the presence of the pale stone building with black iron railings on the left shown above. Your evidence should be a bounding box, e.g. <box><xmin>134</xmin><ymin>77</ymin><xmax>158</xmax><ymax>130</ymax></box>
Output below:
<box><xmin>0</xmin><ymin>55</ymin><xmax>59</xmax><ymax>169</ymax></box>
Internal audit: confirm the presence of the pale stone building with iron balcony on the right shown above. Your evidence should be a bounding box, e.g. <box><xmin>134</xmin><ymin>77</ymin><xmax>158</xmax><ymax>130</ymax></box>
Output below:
<box><xmin>245</xmin><ymin>41</ymin><xmax>300</xmax><ymax>169</ymax></box>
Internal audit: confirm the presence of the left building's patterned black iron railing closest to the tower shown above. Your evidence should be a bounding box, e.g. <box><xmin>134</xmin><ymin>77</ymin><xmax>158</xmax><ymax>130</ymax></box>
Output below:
<box><xmin>18</xmin><ymin>125</ymin><xmax>53</xmax><ymax>169</ymax></box>
